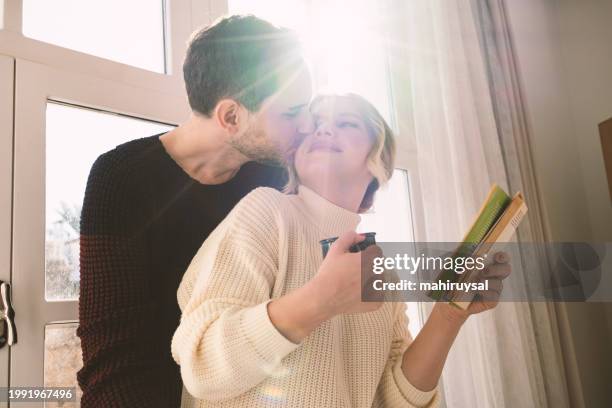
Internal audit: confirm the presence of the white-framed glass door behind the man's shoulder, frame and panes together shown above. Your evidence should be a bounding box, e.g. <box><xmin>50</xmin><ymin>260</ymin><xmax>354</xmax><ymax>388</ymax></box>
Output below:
<box><xmin>10</xmin><ymin>60</ymin><xmax>184</xmax><ymax>407</ymax></box>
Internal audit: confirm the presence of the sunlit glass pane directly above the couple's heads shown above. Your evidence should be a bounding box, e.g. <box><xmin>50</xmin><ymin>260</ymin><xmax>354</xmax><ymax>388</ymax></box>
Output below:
<box><xmin>228</xmin><ymin>0</ymin><xmax>391</xmax><ymax>123</ymax></box>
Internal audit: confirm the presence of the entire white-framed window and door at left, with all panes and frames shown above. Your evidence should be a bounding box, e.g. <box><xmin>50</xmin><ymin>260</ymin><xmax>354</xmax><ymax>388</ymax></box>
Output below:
<box><xmin>0</xmin><ymin>0</ymin><xmax>188</xmax><ymax>398</ymax></box>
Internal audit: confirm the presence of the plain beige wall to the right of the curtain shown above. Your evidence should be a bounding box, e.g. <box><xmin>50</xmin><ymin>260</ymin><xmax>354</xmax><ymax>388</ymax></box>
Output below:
<box><xmin>505</xmin><ymin>0</ymin><xmax>612</xmax><ymax>408</ymax></box>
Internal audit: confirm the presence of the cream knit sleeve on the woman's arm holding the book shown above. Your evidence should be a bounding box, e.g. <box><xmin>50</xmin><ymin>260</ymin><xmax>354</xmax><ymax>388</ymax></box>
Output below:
<box><xmin>378</xmin><ymin>302</ymin><xmax>440</xmax><ymax>408</ymax></box>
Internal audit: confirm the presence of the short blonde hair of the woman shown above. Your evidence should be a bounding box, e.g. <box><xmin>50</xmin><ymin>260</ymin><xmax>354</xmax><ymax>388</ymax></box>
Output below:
<box><xmin>284</xmin><ymin>93</ymin><xmax>395</xmax><ymax>212</ymax></box>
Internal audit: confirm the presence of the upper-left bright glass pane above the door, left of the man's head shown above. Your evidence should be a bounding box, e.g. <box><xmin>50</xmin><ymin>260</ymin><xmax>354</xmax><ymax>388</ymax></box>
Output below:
<box><xmin>23</xmin><ymin>0</ymin><xmax>165</xmax><ymax>73</ymax></box>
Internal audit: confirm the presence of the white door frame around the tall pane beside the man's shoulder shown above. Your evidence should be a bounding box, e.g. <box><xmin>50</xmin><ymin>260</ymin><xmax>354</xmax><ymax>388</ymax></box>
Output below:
<box><xmin>10</xmin><ymin>59</ymin><xmax>190</xmax><ymax>387</ymax></box>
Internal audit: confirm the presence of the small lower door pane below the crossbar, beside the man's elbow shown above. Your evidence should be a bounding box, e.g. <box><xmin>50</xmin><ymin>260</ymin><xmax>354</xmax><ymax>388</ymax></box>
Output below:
<box><xmin>44</xmin><ymin>323</ymin><xmax>83</xmax><ymax>408</ymax></box>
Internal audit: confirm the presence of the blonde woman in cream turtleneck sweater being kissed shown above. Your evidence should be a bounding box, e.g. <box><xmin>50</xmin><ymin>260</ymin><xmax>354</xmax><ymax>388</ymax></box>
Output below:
<box><xmin>172</xmin><ymin>95</ymin><xmax>509</xmax><ymax>408</ymax></box>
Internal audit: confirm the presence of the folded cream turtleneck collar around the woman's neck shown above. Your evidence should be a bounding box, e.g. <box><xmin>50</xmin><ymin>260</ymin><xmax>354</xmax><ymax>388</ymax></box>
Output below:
<box><xmin>297</xmin><ymin>185</ymin><xmax>361</xmax><ymax>239</ymax></box>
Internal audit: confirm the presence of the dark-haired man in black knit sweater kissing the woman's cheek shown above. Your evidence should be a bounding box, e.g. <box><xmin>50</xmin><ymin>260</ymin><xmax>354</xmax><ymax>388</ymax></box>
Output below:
<box><xmin>77</xmin><ymin>16</ymin><xmax>311</xmax><ymax>408</ymax></box>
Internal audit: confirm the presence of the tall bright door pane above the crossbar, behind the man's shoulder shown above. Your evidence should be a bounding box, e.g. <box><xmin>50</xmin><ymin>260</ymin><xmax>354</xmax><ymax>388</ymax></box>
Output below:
<box><xmin>45</xmin><ymin>103</ymin><xmax>172</xmax><ymax>301</ymax></box>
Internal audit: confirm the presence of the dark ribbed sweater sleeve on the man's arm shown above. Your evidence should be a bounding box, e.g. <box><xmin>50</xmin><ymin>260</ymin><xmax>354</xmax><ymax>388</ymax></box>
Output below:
<box><xmin>77</xmin><ymin>153</ymin><xmax>180</xmax><ymax>408</ymax></box>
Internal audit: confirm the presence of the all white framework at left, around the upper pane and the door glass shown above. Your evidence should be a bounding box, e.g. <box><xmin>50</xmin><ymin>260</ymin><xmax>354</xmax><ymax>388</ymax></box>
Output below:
<box><xmin>0</xmin><ymin>0</ymin><xmax>226</xmax><ymax>407</ymax></box>
